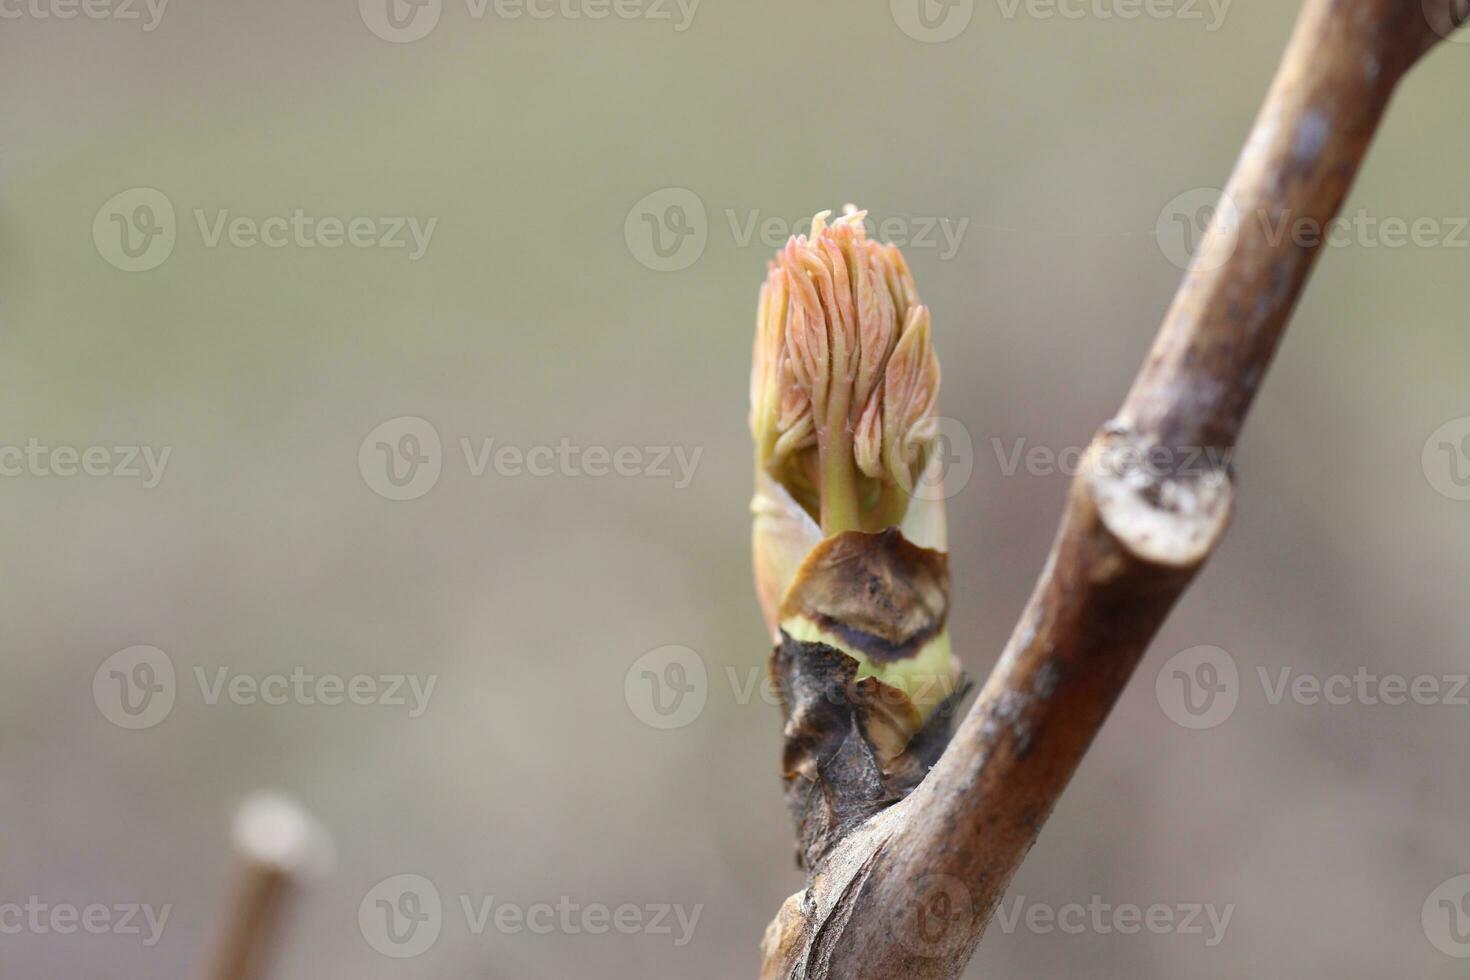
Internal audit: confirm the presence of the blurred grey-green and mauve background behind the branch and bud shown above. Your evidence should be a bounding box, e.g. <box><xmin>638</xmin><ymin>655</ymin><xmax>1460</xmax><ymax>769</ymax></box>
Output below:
<box><xmin>0</xmin><ymin>0</ymin><xmax>1470</xmax><ymax>980</ymax></box>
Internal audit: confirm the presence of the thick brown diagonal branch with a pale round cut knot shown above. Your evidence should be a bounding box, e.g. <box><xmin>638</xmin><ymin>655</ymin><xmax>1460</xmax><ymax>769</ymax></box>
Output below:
<box><xmin>761</xmin><ymin>0</ymin><xmax>1470</xmax><ymax>980</ymax></box>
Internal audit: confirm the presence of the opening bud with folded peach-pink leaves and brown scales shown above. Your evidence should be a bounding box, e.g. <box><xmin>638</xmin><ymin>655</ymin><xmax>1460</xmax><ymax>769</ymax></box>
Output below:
<box><xmin>750</xmin><ymin>209</ymin><xmax>960</xmax><ymax>746</ymax></box>
